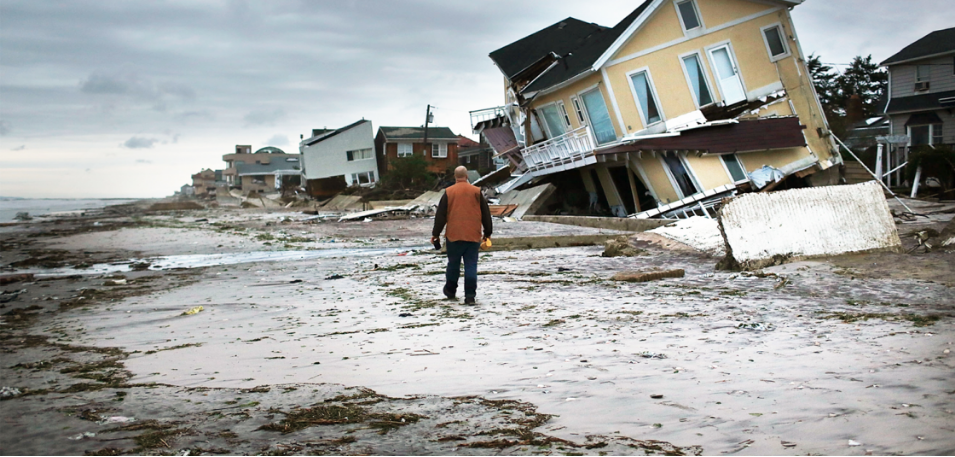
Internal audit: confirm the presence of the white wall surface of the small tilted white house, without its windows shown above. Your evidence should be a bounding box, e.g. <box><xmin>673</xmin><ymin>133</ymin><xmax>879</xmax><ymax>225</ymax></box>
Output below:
<box><xmin>301</xmin><ymin>121</ymin><xmax>381</xmax><ymax>185</ymax></box>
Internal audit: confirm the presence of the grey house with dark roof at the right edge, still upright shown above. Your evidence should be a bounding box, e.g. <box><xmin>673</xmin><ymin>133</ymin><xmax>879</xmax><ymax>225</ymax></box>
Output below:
<box><xmin>882</xmin><ymin>28</ymin><xmax>955</xmax><ymax>185</ymax></box>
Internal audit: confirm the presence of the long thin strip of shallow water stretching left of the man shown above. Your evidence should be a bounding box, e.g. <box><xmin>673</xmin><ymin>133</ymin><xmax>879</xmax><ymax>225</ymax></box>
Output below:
<box><xmin>14</xmin><ymin>245</ymin><xmax>430</xmax><ymax>277</ymax></box>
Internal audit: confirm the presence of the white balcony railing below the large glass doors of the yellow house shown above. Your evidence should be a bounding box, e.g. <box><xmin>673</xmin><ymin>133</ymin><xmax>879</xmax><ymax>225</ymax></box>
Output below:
<box><xmin>521</xmin><ymin>126</ymin><xmax>597</xmax><ymax>176</ymax></box>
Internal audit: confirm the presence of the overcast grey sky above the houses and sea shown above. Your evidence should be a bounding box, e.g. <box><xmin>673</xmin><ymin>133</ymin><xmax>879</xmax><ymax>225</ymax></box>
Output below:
<box><xmin>0</xmin><ymin>0</ymin><xmax>955</xmax><ymax>197</ymax></box>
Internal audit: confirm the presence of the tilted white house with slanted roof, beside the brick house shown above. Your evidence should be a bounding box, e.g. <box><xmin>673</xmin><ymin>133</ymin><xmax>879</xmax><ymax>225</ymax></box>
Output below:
<box><xmin>299</xmin><ymin>119</ymin><xmax>380</xmax><ymax>198</ymax></box>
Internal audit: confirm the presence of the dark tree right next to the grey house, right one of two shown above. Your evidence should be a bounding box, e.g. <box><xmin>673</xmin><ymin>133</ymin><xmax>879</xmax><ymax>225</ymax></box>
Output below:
<box><xmin>832</xmin><ymin>54</ymin><xmax>889</xmax><ymax>117</ymax></box>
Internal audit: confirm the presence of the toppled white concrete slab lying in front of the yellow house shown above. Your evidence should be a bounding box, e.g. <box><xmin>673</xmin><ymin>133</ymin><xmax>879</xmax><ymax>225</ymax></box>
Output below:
<box><xmin>720</xmin><ymin>181</ymin><xmax>902</xmax><ymax>269</ymax></box>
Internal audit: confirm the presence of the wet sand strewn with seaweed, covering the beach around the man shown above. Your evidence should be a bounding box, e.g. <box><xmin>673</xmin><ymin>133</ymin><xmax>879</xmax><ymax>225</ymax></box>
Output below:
<box><xmin>0</xmin><ymin>205</ymin><xmax>955</xmax><ymax>455</ymax></box>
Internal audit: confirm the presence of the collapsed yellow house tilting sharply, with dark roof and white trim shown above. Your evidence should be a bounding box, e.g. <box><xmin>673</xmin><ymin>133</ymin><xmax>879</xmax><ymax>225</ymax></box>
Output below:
<box><xmin>471</xmin><ymin>0</ymin><xmax>842</xmax><ymax>218</ymax></box>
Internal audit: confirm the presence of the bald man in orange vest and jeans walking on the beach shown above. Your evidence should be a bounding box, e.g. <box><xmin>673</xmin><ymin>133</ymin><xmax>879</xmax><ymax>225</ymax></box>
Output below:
<box><xmin>431</xmin><ymin>167</ymin><xmax>493</xmax><ymax>305</ymax></box>
